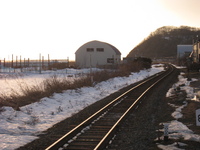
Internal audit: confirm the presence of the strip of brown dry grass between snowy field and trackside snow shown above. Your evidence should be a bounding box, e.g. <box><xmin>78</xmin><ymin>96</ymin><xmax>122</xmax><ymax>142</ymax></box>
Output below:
<box><xmin>0</xmin><ymin>62</ymin><xmax>150</xmax><ymax>110</ymax></box>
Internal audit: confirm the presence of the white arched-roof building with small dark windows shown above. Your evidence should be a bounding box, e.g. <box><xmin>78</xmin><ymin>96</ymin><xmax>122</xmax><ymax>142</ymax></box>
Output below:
<box><xmin>75</xmin><ymin>41</ymin><xmax>121</xmax><ymax>68</ymax></box>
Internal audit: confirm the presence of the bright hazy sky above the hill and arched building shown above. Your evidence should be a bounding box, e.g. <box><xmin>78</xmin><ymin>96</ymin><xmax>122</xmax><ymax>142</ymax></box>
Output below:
<box><xmin>0</xmin><ymin>0</ymin><xmax>200</xmax><ymax>60</ymax></box>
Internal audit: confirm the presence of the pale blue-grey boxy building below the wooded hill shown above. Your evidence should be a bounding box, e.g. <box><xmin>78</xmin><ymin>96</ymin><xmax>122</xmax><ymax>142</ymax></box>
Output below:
<box><xmin>177</xmin><ymin>45</ymin><xmax>193</xmax><ymax>59</ymax></box>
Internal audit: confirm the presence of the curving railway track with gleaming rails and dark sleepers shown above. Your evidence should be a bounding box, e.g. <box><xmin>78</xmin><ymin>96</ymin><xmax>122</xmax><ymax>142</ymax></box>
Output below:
<box><xmin>46</xmin><ymin>65</ymin><xmax>173</xmax><ymax>150</ymax></box>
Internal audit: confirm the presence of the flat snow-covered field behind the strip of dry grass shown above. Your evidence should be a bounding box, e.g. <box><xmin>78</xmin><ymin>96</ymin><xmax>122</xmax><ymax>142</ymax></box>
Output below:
<box><xmin>0</xmin><ymin>68</ymin><xmax>101</xmax><ymax>95</ymax></box>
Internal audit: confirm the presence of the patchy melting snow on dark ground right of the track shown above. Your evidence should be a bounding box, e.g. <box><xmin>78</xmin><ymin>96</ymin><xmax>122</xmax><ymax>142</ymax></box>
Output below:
<box><xmin>158</xmin><ymin>73</ymin><xmax>200</xmax><ymax>150</ymax></box>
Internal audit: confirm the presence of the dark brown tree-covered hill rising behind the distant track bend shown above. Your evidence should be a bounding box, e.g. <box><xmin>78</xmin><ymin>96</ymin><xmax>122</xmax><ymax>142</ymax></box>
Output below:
<box><xmin>127</xmin><ymin>26</ymin><xmax>200</xmax><ymax>59</ymax></box>
